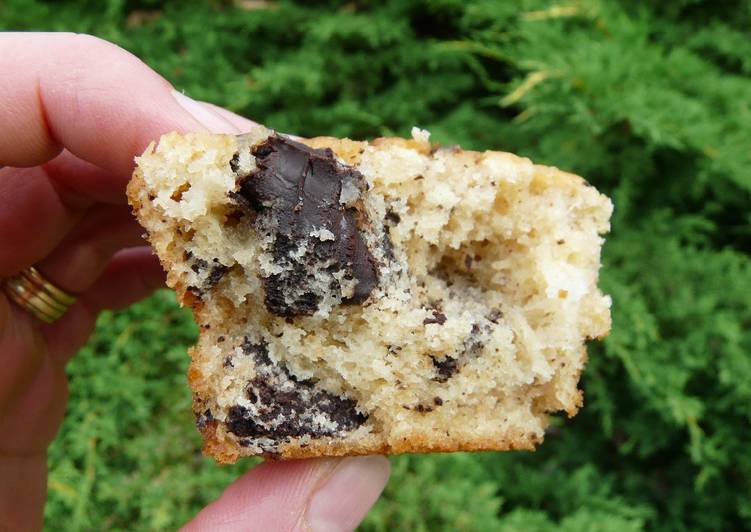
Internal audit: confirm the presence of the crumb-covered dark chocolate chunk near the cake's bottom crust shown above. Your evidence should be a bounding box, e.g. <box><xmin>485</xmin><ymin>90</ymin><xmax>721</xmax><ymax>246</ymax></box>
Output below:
<box><xmin>227</xmin><ymin>338</ymin><xmax>367</xmax><ymax>440</ymax></box>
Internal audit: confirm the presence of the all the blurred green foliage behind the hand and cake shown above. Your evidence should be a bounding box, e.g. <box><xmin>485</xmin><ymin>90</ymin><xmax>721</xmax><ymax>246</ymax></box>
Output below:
<box><xmin>0</xmin><ymin>0</ymin><xmax>751</xmax><ymax>531</ymax></box>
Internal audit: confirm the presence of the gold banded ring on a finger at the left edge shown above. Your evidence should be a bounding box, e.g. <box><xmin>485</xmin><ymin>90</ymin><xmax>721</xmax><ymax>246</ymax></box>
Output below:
<box><xmin>3</xmin><ymin>266</ymin><xmax>76</xmax><ymax>323</ymax></box>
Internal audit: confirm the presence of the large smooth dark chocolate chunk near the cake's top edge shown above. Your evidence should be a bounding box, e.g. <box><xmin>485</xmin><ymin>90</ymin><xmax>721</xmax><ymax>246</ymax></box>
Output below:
<box><xmin>238</xmin><ymin>134</ymin><xmax>378</xmax><ymax>317</ymax></box>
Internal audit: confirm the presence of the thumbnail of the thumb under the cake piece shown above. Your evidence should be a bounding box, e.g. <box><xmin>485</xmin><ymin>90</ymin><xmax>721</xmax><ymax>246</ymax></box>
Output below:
<box><xmin>306</xmin><ymin>456</ymin><xmax>389</xmax><ymax>532</ymax></box>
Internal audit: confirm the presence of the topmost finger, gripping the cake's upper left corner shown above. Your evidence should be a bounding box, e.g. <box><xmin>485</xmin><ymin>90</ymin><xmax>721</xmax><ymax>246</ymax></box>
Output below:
<box><xmin>0</xmin><ymin>33</ymin><xmax>207</xmax><ymax>178</ymax></box>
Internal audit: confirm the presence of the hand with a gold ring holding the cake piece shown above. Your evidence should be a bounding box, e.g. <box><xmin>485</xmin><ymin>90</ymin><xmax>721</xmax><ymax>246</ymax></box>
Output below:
<box><xmin>0</xmin><ymin>33</ymin><xmax>388</xmax><ymax>530</ymax></box>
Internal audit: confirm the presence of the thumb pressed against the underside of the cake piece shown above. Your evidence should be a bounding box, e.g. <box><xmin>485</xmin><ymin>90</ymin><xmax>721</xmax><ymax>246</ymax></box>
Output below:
<box><xmin>183</xmin><ymin>456</ymin><xmax>389</xmax><ymax>532</ymax></box>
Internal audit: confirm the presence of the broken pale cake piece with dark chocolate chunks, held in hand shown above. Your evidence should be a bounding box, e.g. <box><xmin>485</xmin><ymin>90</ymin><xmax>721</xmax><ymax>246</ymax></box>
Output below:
<box><xmin>128</xmin><ymin>126</ymin><xmax>612</xmax><ymax>463</ymax></box>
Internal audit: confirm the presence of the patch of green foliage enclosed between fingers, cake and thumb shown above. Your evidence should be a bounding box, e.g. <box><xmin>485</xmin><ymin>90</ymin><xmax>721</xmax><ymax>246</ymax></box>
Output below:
<box><xmin>41</xmin><ymin>292</ymin><xmax>252</xmax><ymax>530</ymax></box>
